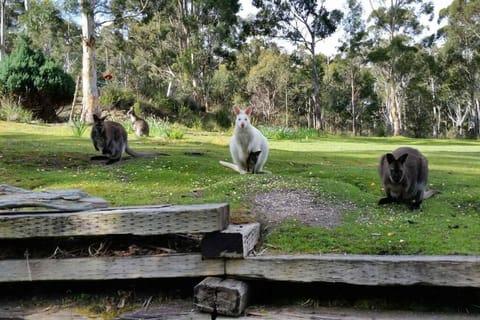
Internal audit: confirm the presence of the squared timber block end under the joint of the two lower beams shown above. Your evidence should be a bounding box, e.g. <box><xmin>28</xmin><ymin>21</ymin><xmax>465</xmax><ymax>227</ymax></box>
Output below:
<box><xmin>193</xmin><ymin>277</ymin><xmax>248</xmax><ymax>317</ymax></box>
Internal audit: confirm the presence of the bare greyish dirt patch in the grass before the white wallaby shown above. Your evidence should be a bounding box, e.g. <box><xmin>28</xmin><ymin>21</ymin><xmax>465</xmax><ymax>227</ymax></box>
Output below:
<box><xmin>251</xmin><ymin>190</ymin><xmax>351</xmax><ymax>229</ymax></box>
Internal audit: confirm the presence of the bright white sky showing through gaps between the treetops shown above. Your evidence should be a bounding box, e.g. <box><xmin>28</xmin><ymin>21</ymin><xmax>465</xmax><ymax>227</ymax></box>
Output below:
<box><xmin>240</xmin><ymin>0</ymin><xmax>452</xmax><ymax>56</ymax></box>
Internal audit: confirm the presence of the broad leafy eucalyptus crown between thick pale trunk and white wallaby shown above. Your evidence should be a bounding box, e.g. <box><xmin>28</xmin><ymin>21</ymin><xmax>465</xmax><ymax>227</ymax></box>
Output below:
<box><xmin>130</xmin><ymin>0</ymin><xmax>240</xmax><ymax>110</ymax></box>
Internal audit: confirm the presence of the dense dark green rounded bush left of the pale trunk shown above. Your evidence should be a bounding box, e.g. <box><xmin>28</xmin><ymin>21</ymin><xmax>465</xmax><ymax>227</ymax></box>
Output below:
<box><xmin>0</xmin><ymin>37</ymin><xmax>75</xmax><ymax>121</ymax></box>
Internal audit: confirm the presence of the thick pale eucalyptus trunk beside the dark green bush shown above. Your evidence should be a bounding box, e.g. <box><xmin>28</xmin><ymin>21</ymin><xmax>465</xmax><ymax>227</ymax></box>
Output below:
<box><xmin>80</xmin><ymin>0</ymin><xmax>100</xmax><ymax>123</ymax></box>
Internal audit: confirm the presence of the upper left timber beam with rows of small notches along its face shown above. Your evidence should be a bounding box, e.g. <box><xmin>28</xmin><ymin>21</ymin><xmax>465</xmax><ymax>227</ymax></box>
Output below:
<box><xmin>0</xmin><ymin>203</ymin><xmax>229</xmax><ymax>239</ymax></box>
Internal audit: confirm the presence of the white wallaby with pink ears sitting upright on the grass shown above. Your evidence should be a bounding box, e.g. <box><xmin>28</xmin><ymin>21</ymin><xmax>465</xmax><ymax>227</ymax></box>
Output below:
<box><xmin>220</xmin><ymin>106</ymin><xmax>270</xmax><ymax>174</ymax></box>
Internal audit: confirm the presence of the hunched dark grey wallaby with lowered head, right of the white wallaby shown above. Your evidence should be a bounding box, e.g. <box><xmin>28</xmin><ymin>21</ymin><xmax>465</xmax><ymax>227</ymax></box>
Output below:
<box><xmin>378</xmin><ymin>147</ymin><xmax>437</xmax><ymax>209</ymax></box>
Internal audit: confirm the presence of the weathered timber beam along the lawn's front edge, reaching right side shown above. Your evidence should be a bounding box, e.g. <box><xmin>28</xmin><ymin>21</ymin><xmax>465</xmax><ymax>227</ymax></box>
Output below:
<box><xmin>225</xmin><ymin>255</ymin><xmax>480</xmax><ymax>287</ymax></box>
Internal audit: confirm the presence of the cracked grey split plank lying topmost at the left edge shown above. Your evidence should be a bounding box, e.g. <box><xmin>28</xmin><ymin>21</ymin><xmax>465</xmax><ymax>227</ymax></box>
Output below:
<box><xmin>0</xmin><ymin>184</ymin><xmax>108</xmax><ymax>211</ymax></box>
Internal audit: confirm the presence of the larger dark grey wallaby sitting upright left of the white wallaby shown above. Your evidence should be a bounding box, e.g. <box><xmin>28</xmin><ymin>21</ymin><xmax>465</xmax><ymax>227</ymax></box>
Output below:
<box><xmin>90</xmin><ymin>114</ymin><xmax>141</xmax><ymax>164</ymax></box>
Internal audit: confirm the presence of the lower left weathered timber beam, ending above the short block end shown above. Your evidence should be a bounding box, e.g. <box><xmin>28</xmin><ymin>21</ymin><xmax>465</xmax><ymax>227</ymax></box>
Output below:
<box><xmin>0</xmin><ymin>254</ymin><xmax>224</xmax><ymax>282</ymax></box>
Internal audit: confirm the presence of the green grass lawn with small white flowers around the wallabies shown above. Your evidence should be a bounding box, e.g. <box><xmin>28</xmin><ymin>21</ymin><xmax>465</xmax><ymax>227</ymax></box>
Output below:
<box><xmin>0</xmin><ymin>122</ymin><xmax>480</xmax><ymax>254</ymax></box>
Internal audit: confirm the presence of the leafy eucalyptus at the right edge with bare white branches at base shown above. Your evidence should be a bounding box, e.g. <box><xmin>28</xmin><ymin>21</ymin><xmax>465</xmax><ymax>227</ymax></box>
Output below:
<box><xmin>440</xmin><ymin>0</ymin><xmax>480</xmax><ymax>138</ymax></box>
